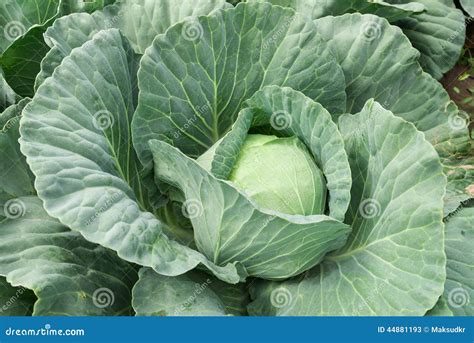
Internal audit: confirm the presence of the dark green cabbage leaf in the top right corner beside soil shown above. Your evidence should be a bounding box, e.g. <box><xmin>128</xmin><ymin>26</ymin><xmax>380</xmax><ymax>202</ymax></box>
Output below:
<box><xmin>386</xmin><ymin>0</ymin><xmax>466</xmax><ymax>79</ymax></box>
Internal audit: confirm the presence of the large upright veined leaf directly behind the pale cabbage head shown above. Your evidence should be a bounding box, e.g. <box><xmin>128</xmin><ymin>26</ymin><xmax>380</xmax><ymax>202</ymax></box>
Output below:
<box><xmin>133</xmin><ymin>3</ymin><xmax>345</xmax><ymax>166</ymax></box>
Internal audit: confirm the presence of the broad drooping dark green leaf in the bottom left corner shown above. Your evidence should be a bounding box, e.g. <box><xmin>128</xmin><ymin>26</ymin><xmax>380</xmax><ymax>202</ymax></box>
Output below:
<box><xmin>0</xmin><ymin>197</ymin><xmax>136</xmax><ymax>316</ymax></box>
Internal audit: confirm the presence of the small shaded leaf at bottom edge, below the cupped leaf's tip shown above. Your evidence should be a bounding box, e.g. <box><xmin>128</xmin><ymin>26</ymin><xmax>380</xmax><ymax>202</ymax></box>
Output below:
<box><xmin>133</xmin><ymin>268</ymin><xmax>248</xmax><ymax>316</ymax></box>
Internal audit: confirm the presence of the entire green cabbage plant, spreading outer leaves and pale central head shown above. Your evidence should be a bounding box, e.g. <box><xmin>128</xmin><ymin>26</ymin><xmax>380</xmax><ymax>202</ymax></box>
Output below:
<box><xmin>0</xmin><ymin>0</ymin><xmax>474</xmax><ymax>316</ymax></box>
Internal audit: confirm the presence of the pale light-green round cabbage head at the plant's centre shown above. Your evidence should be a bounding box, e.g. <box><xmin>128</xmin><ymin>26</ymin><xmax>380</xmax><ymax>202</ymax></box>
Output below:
<box><xmin>225</xmin><ymin>135</ymin><xmax>326</xmax><ymax>215</ymax></box>
